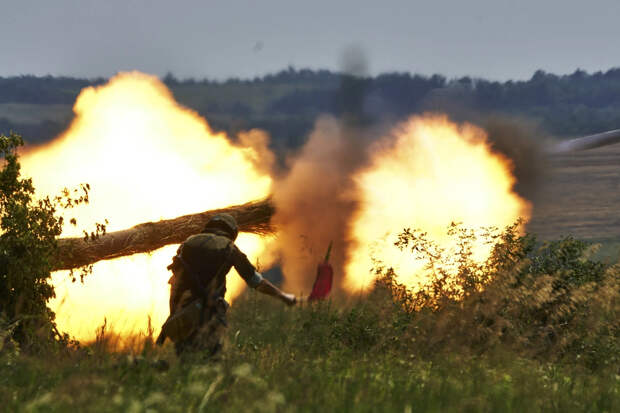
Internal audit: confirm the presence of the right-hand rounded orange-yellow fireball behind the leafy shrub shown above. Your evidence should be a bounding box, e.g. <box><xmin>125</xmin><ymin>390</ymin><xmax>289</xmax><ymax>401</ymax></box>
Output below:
<box><xmin>345</xmin><ymin>115</ymin><xmax>531</xmax><ymax>293</ymax></box>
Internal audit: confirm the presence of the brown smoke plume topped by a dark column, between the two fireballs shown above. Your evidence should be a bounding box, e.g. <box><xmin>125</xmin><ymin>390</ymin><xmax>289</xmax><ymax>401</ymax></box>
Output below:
<box><xmin>273</xmin><ymin>48</ymin><xmax>373</xmax><ymax>293</ymax></box>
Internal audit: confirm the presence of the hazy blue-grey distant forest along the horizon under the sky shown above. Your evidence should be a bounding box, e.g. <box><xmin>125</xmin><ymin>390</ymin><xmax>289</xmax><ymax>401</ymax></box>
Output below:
<box><xmin>0</xmin><ymin>68</ymin><xmax>620</xmax><ymax>149</ymax></box>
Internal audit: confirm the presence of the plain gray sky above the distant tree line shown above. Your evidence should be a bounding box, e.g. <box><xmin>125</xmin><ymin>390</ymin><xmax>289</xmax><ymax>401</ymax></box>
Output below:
<box><xmin>0</xmin><ymin>0</ymin><xmax>620</xmax><ymax>80</ymax></box>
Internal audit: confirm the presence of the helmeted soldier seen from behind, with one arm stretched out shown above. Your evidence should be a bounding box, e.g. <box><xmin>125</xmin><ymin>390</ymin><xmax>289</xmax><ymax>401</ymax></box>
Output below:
<box><xmin>157</xmin><ymin>214</ymin><xmax>297</xmax><ymax>356</ymax></box>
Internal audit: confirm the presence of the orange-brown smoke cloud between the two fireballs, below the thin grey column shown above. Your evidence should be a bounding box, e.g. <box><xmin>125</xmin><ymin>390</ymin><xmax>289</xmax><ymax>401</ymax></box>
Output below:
<box><xmin>273</xmin><ymin>117</ymin><xmax>355</xmax><ymax>292</ymax></box>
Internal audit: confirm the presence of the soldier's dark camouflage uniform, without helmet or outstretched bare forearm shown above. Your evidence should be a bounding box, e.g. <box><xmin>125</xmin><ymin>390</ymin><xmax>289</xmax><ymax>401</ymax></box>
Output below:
<box><xmin>168</xmin><ymin>224</ymin><xmax>262</xmax><ymax>356</ymax></box>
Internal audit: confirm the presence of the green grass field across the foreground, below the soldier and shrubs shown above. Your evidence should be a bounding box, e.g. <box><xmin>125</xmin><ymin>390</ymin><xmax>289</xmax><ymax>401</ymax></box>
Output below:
<box><xmin>0</xmin><ymin>294</ymin><xmax>620</xmax><ymax>412</ymax></box>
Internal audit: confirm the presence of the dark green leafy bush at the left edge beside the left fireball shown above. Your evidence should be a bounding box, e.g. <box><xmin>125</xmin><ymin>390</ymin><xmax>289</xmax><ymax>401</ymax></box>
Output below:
<box><xmin>0</xmin><ymin>133</ymin><xmax>89</xmax><ymax>350</ymax></box>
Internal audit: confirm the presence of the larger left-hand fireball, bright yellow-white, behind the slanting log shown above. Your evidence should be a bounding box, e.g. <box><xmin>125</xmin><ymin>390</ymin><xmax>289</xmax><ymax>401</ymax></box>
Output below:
<box><xmin>21</xmin><ymin>72</ymin><xmax>272</xmax><ymax>340</ymax></box>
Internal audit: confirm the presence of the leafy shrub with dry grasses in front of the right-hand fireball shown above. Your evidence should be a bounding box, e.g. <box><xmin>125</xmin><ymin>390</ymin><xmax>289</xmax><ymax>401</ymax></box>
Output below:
<box><xmin>376</xmin><ymin>223</ymin><xmax>620</xmax><ymax>367</ymax></box>
